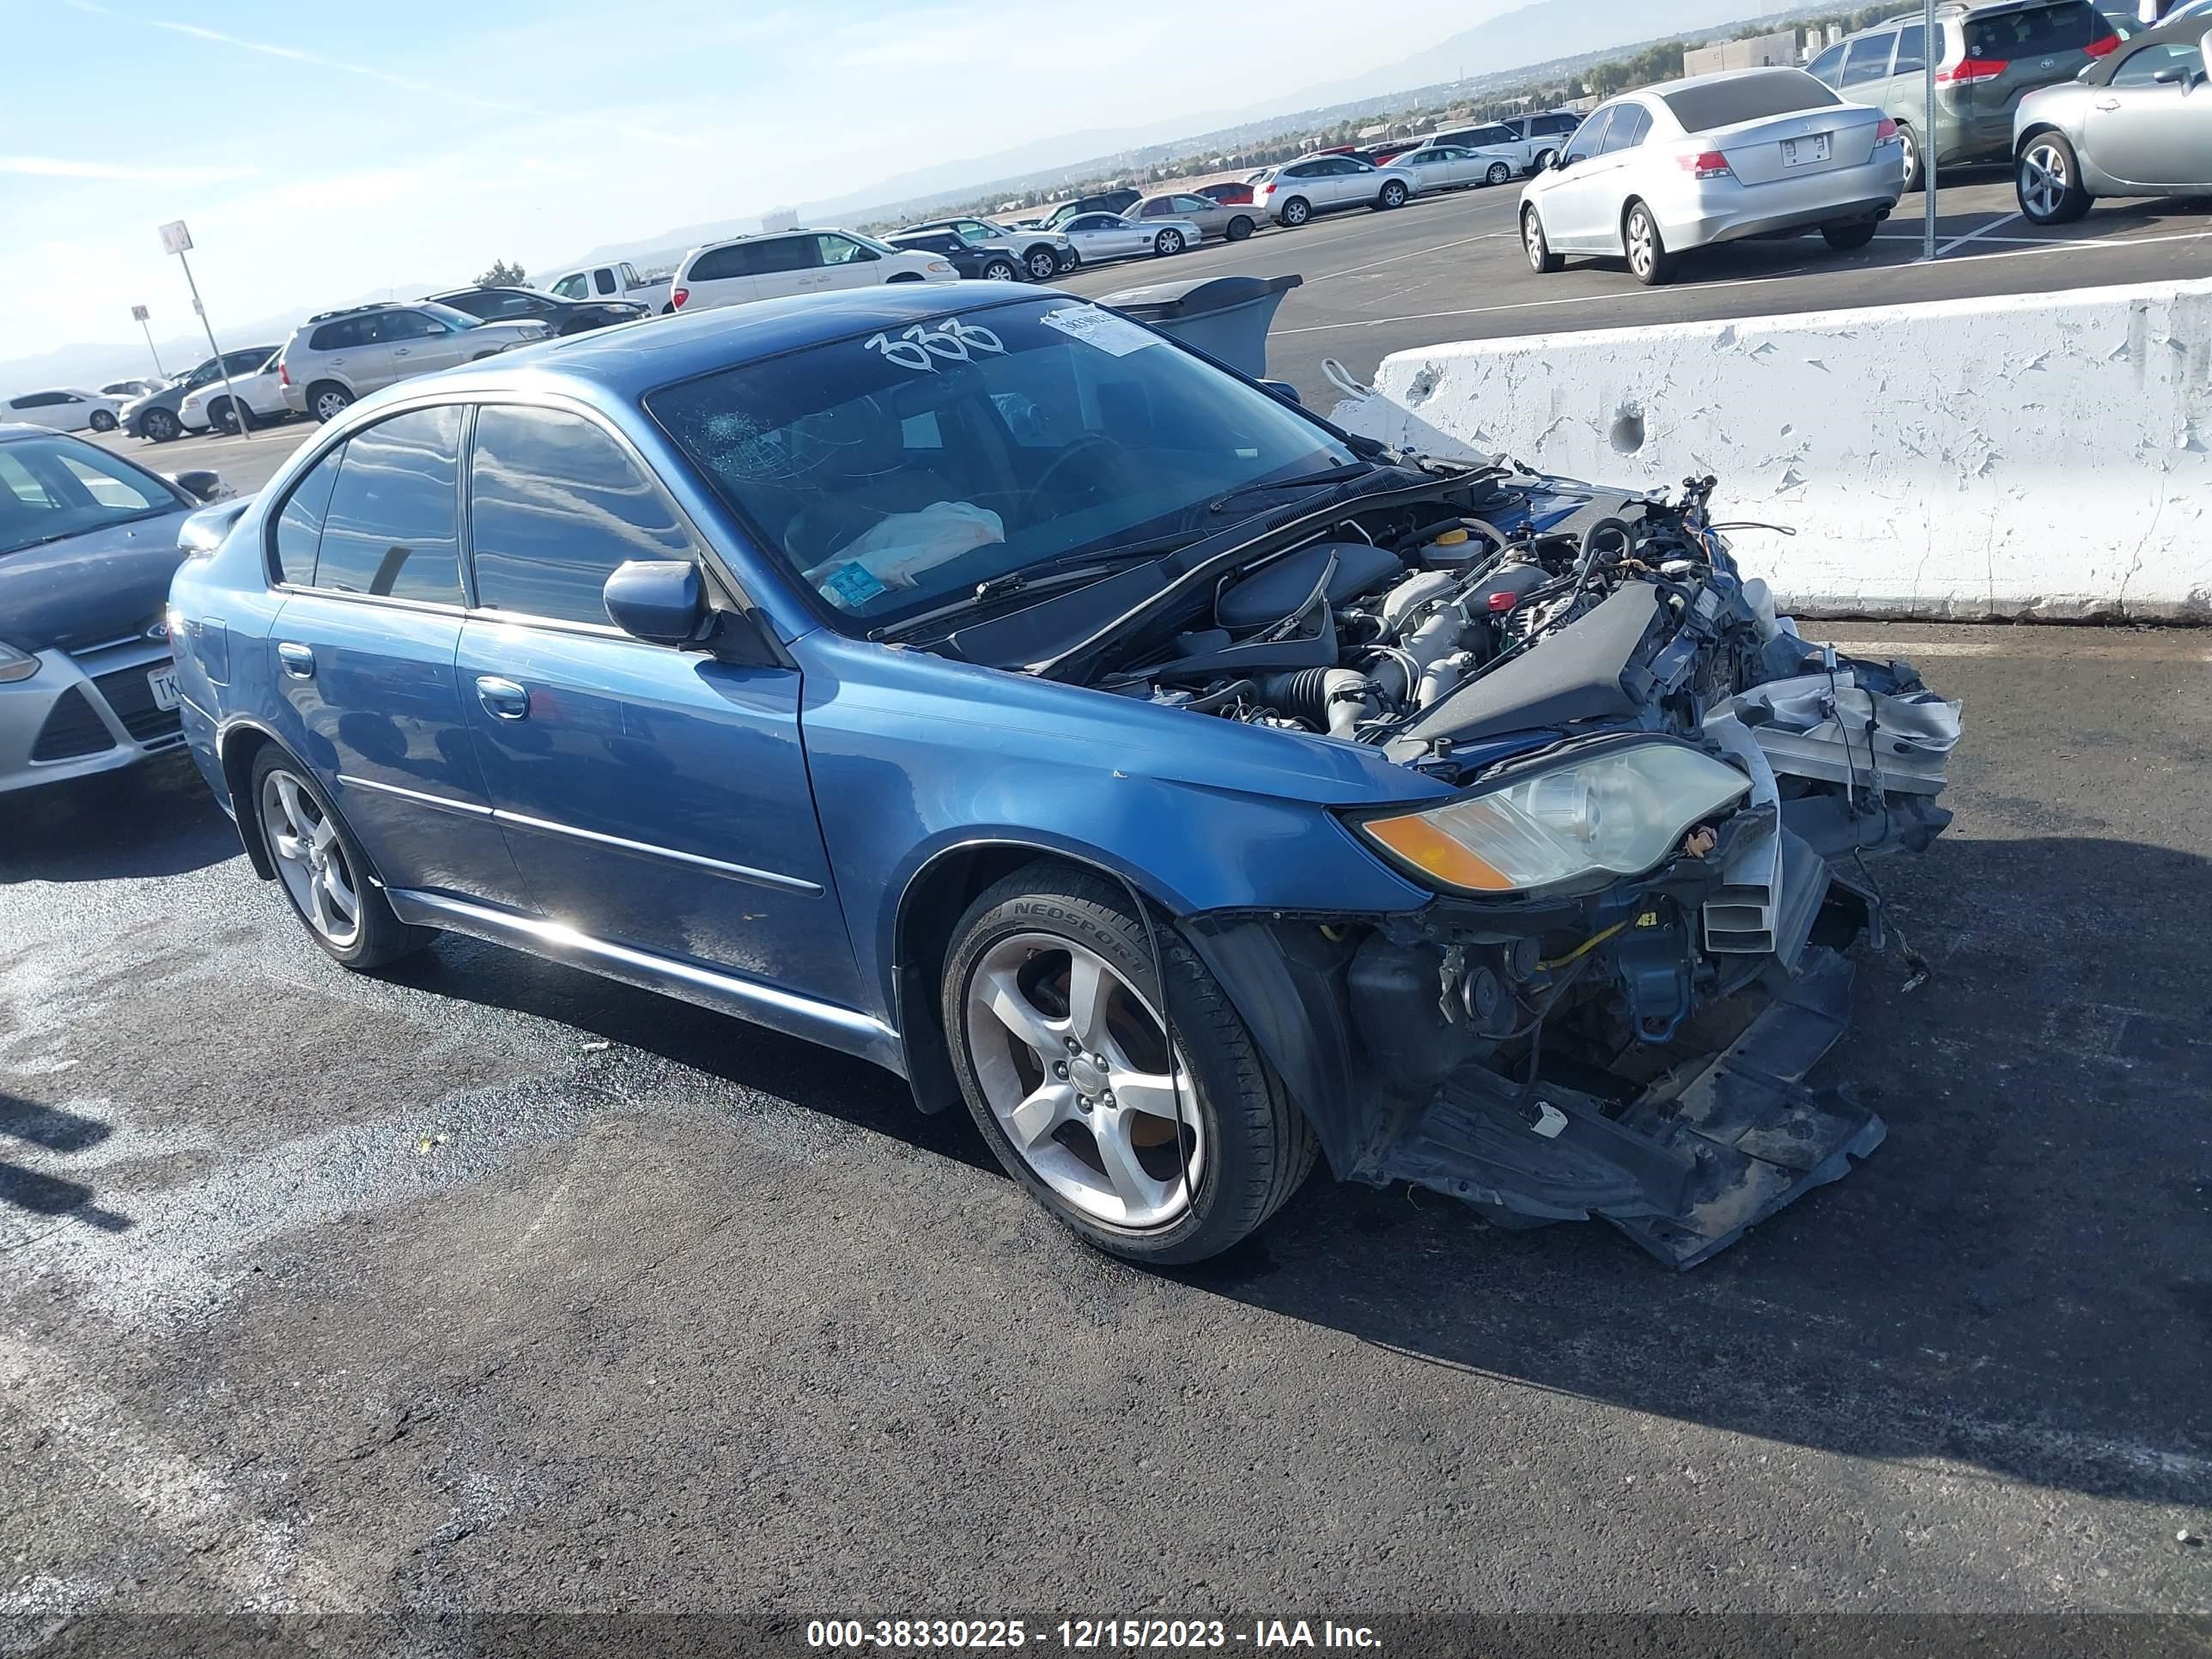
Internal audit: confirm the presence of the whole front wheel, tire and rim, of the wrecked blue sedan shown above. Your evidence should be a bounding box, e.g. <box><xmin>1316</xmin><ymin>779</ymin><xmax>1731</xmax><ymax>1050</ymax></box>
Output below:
<box><xmin>942</xmin><ymin>865</ymin><xmax>1316</xmax><ymax>1265</ymax></box>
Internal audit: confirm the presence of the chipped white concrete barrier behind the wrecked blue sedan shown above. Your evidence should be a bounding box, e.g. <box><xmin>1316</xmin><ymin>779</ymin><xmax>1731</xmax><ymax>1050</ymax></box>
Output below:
<box><xmin>1336</xmin><ymin>281</ymin><xmax>2212</xmax><ymax>622</ymax></box>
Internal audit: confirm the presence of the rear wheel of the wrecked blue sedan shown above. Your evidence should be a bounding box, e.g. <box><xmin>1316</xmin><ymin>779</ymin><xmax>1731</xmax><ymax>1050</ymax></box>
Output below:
<box><xmin>252</xmin><ymin>744</ymin><xmax>435</xmax><ymax>971</ymax></box>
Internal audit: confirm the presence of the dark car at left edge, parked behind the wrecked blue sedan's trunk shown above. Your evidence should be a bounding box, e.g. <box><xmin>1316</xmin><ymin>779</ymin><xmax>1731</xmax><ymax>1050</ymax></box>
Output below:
<box><xmin>0</xmin><ymin>422</ymin><xmax>222</xmax><ymax>794</ymax></box>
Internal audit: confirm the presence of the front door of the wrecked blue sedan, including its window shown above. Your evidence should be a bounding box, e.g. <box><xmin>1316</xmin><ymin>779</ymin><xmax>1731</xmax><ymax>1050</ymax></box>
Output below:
<box><xmin>460</xmin><ymin>404</ymin><xmax>858</xmax><ymax>1005</ymax></box>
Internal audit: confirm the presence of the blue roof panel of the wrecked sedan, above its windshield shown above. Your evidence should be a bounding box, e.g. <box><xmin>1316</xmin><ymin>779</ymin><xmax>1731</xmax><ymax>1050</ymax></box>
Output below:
<box><xmin>435</xmin><ymin>283</ymin><xmax>1057</xmax><ymax>403</ymax></box>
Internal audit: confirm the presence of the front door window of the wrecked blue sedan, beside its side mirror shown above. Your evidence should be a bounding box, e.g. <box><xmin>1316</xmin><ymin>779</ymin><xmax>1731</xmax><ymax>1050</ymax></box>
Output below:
<box><xmin>469</xmin><ymin>407</ymin><xmax>695</xmax><ymax>626</ymax></box>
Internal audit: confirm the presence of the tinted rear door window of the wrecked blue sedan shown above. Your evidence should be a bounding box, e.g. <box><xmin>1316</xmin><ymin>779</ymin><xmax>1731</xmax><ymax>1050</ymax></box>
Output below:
<box><xmin>314</xmin><ymin>404</ymin><xmax>460</xmax><ymax>604</ymax></box>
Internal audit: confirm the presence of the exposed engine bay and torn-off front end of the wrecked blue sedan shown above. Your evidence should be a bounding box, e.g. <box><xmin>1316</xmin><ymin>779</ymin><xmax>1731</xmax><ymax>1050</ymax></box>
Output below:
<box><xmin>1066</xmin><ymin>469</ymin><xmax>1960</xmax><ymax>1265</ymax></box>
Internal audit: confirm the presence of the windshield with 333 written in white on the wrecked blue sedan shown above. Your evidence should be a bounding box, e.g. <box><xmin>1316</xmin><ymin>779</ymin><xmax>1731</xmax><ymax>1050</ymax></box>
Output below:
<box><xmin>646</xmin><ymin>299</ymin><xmax>1356</xmax><ymax>629</ymax></box>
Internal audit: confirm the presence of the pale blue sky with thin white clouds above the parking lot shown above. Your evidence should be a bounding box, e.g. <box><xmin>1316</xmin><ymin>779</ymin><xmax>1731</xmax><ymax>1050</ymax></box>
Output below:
<box><xmin>0</xmin><ymin>0</ymin><xmax>1504</xmax><ymax>362</ymax></box>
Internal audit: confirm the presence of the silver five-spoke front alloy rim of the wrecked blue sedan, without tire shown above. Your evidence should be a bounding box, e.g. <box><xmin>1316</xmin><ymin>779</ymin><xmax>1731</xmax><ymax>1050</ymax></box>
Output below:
<box><xmin>964</xmin><ymin>933</ymin><xmax>1207</xmax><ymax>1230</ymax></box>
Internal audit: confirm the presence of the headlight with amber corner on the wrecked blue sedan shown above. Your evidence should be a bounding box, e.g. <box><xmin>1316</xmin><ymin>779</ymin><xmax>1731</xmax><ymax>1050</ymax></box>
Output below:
<box><xmin>1358</xmin><ymin>741</ymin><xmax>1752</xmax><ymax>894</ymax></box>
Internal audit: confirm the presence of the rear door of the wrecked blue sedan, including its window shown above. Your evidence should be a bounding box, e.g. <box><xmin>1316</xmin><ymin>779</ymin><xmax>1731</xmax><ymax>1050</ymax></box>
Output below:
<box><xmin>257</xmin><ymin>404</ymin><xmax>525</xmax><ymax>905</ymax></box>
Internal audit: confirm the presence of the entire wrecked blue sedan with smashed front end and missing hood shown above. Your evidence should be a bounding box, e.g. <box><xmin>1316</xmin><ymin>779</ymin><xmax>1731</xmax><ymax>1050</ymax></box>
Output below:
<box><xmin>170</xmin><ymin>283</ymin><xmax>1960</xmax><ymax>1265</ymax></box>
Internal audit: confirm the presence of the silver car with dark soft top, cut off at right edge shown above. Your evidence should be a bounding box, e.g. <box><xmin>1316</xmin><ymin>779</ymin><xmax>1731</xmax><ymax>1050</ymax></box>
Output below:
<box><xmin>2013</xmin><ymin>15</ymin><xmax>2212</xmax><ymax>226</ymax></box>
